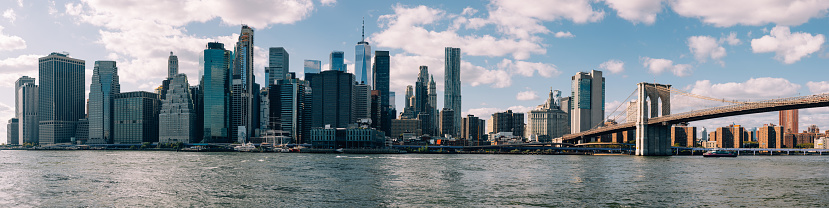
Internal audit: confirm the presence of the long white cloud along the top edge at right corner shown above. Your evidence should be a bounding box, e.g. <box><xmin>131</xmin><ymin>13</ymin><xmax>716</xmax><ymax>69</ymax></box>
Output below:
<box><xmin>670</xmin><ymin>0</ymin><xmax>829</xmax><ymax>27</ymax></box>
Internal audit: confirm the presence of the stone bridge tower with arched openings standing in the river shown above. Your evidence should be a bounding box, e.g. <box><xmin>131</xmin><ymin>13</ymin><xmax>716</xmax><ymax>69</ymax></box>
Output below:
<box><xmin>636</xmin><ymin>82</ymin><xmax>671</xmax><ymax>156</ymax></box>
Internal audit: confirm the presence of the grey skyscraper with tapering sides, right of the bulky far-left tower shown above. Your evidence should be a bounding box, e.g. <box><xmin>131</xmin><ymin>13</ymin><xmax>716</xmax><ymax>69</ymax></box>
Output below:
<box><xmin>86</xmin><ymin>61</ymin><xmax>121</xmax><ymax>144</ymax></box>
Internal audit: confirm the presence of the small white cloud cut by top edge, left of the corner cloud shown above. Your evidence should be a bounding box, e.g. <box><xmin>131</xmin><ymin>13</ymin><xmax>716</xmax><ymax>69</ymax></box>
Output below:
<box><xmin>605</xmin><ymin>0</ymin><xmax>663</xmax><ymax>25</ymax></box>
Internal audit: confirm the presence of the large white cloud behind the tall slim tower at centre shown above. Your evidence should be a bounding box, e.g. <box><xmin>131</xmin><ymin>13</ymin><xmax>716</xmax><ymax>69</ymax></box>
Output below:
<box><xmin>380</xmin><ymin>5</ymin><xmax>561</xmax><ymax>91</ymax></box>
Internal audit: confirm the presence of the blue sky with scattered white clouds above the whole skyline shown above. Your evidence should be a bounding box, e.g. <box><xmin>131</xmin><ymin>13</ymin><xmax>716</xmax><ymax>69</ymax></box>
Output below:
<box><xmin>0</xmin><ymin>0</ymin><xmax>829</xmax><ymax>141</ymax></box>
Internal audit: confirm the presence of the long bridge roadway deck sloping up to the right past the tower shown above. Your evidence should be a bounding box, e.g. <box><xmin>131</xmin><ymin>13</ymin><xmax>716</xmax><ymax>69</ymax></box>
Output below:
<box><xmin>562</xmin><ymin>93</ymin><xmax>829</xmax><ymax>142</ymax></box>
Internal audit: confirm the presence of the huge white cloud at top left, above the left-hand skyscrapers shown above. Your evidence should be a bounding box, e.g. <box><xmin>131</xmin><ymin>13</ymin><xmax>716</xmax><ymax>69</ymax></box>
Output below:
<box><xmin>65</xmin><ymin>0</ymin><xmax>313</xmax><ymax>90</ymax></box>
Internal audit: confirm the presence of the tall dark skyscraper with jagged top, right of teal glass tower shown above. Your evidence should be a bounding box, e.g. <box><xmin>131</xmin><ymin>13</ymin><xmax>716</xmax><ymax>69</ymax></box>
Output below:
<box><xmin>230</xmin><ymin>25</ymin><xmax>258</xmax><ymax>143</ymax></box>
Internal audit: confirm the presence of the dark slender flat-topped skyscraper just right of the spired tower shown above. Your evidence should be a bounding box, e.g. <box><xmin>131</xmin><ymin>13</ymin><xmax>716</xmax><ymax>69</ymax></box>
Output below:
<box><xmin>372</xmin><ymin>51</ymin><xmax>395</xmax><ymax>136</ymax></box>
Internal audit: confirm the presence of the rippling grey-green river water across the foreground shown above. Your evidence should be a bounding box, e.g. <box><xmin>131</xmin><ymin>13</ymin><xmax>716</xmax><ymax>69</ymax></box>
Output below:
<box><xmin>0</xmin><ymin>150</ymin><xmax>829</xmax><ymax>207</ymax></box>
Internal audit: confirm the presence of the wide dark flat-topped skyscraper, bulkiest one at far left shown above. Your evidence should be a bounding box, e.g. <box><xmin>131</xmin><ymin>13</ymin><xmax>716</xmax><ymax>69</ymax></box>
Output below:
<box><xmin>37</xmin><ymin>53</ymin><xmax>86</xmax><ymax>145</ymax></box>
